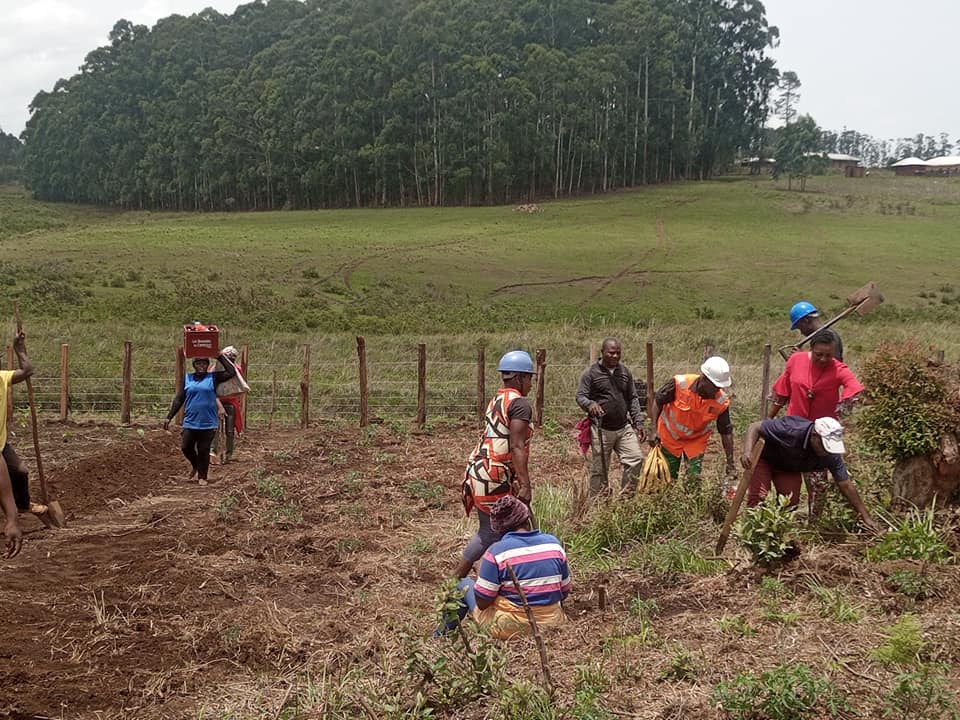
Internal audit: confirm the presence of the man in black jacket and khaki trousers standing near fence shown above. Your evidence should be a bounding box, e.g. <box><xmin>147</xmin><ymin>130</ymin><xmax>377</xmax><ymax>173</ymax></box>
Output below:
<box><xmin>577</xmin><ymin>338</ymin><xmax>645</xmax><ymax>495</ymax></box>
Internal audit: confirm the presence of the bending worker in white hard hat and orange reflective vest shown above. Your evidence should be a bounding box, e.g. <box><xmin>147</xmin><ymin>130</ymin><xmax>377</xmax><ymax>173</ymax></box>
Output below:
<box><xmin>650</xmin><ymin>356</ymin><xmax>735</xmax><ymax>484</ymax></box>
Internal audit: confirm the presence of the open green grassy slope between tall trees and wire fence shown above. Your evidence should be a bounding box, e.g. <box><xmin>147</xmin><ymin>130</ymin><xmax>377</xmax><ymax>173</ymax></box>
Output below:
<box><xmin>0</xmin><ymin>177</ymin><xmax>960</xmax><ymax>332</ymax></box>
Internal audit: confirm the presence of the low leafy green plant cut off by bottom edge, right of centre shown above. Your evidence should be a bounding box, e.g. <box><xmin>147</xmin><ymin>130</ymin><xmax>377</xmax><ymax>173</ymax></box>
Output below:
<box><xmin>710</xmin><ymin>664</ymin><xmax>849</xmax><ymax>720</ymax></box>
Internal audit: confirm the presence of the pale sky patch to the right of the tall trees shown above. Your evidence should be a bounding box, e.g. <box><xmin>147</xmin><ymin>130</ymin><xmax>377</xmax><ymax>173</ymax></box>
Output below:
<box><xmin>762</xmin><ymin>0</ymin><xmax>960</xmax><ymax>143</ymax></box>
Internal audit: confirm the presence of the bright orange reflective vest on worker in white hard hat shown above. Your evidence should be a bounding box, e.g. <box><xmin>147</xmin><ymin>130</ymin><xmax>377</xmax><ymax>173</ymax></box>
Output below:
<box><xmin>657</xmin><ymin>375</ymin><xmax>730</xmax><ymax>458</ymax></box>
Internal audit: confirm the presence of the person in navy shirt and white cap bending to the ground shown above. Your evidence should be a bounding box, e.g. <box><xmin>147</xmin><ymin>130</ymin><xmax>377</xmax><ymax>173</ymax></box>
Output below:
<box><xmin>740</xmin><ymin>415</ymin><xmax>879</xmax><ymax>532</ymax></box>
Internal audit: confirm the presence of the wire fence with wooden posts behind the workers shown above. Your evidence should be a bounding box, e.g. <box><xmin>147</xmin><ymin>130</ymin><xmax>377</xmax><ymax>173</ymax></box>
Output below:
<box><xmin>5</xmin><ymin>338</ymin><xmax>780</xmax><ymax>426</ymax></box>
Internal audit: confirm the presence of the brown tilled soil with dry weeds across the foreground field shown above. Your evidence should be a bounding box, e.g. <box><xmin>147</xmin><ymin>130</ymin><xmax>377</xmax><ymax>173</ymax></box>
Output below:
<box><xmin>0</xmin><ymin>423</ymin><xmax>960</xmax><ymax>719</ymax></box>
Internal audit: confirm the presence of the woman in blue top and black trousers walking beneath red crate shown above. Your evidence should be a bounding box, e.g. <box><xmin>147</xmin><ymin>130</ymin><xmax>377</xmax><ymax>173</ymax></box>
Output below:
<box><xmin>163</xmin><ymin>353</ymin><xmax>237</xmax><ymax>485</ymax></box>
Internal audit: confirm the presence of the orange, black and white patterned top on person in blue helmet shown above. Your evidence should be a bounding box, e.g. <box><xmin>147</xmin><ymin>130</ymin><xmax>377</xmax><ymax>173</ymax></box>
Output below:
<box><xmin>463</xmin><ymin>388</ymin><xmax>533</xmax><ymax>515</ymax></box>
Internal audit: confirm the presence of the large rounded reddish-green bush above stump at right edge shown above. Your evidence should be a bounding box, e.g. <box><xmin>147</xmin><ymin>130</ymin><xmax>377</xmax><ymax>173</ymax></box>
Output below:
<box><xmin>859</xmin><ymin>341</ymin><xmax>958</xmax><ymax>460</ymax></box>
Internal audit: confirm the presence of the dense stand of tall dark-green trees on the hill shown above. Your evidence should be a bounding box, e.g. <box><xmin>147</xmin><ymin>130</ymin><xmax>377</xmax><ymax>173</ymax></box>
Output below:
<box><xmin>22</xmin><ymin>0</ymin><xmax>779</xmax><ymax>210</ymax></box>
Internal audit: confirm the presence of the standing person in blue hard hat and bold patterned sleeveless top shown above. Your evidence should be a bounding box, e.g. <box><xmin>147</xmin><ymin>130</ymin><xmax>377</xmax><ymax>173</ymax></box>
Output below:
<box><xmin>456</xmin><ymin>350</ymin><xmax>536</xmax><ymax>578</ymax></box>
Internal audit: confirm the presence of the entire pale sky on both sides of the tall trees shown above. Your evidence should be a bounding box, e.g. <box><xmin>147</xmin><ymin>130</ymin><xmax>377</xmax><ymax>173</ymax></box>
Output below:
<box><xmin>0</xmin><ymin>0</ymin><xmax>960</xmax><ymax>146</ymax></box>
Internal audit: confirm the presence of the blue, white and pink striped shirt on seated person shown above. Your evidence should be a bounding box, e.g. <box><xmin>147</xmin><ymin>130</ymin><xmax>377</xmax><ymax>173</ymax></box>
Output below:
<box><xmin>474</xmin><ymin>530</ymin><xmax>570</xmax><ymax>607</ymax></box>
